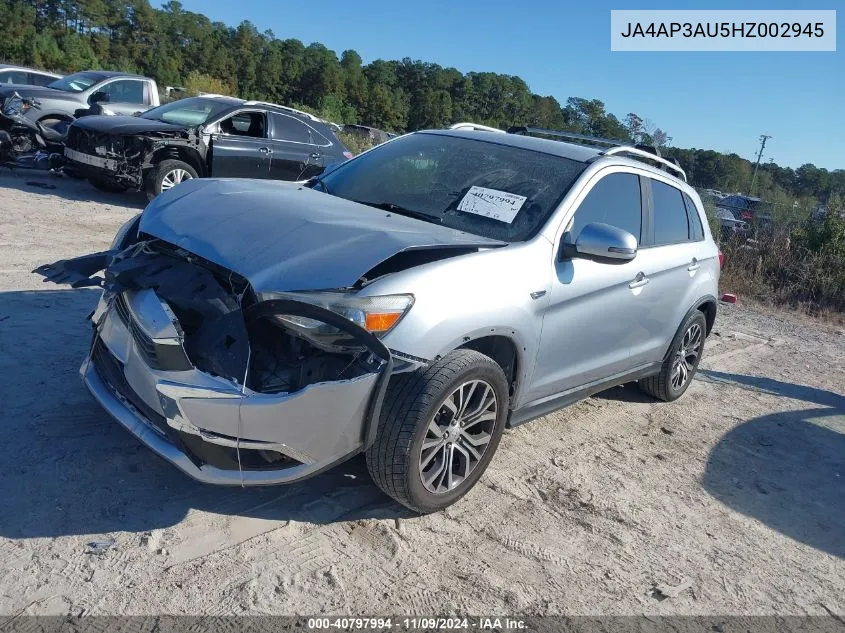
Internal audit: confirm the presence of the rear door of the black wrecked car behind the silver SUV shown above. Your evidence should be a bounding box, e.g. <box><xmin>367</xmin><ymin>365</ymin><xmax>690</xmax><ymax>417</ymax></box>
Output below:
<box><xmin>269</xmin><ymin>112</ymin><xmax>324</xmax><ymax>180</ymax></box>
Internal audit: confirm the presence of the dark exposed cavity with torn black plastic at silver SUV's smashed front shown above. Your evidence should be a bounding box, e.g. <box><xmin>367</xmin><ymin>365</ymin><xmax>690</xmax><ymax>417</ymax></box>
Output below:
<box><xmin>36</xmin><ymin>239</ymin><xmax>389</xmax><ymax>394</ymax></box>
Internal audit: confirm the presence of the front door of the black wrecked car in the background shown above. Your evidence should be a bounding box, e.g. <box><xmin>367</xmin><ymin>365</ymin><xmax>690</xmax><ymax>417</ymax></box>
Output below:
<box><xmin>211</xmin><ymin>109</ymin><xmax>273</xmax><ymax>178</ymax></box>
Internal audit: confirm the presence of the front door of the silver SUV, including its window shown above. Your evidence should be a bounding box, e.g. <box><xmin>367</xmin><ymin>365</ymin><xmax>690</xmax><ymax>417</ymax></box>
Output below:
<box><xmin>527</xmin><ymin>172</ymin><xmax>649</xmax><ymax>401</ymax></box>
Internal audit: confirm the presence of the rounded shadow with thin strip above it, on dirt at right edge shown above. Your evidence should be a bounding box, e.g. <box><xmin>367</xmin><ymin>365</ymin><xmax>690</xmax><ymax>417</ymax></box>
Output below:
<box><xmin>700</xmin><ymin>370</ymin><xmax>845</xmax><ymax>558</ymax></box>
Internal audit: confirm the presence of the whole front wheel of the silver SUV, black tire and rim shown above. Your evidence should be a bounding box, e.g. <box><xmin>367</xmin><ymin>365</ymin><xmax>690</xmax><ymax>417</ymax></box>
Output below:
<box><xmin>366</xmin><ymin>350</ymin><xmax>508</xmax><ymax>513</ymax></box>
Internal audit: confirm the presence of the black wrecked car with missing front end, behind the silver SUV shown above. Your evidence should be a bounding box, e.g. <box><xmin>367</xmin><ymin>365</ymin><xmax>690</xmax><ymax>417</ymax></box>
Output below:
<box><xmin>65</xmin><ymin>95</ymin><xmax>352</xmax><ymax>200</ymax></box>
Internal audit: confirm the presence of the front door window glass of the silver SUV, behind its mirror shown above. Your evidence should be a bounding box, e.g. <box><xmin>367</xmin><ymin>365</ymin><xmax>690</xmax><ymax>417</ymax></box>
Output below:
<box><xmin>569</xmin><ymin>173</ymin><xmax>643</xmax><ymax>242</ymax></box>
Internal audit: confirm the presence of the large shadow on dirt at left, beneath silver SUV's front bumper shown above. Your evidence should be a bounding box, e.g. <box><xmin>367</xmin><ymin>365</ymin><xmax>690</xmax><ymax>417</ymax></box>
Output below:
<box><xmin>0</xmin><ymin>290</ymin><xmax>411</xmax><ymax>538</ymax></box>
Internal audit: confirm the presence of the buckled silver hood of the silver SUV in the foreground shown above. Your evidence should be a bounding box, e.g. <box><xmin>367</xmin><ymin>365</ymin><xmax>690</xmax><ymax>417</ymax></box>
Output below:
<box><xmin>140</xmin><ymin>179</ymin><xmax>503</xmax><ymax>292</ymax></box>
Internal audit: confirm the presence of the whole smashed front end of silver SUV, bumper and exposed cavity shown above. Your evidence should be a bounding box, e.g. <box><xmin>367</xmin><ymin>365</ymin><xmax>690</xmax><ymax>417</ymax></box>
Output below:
<box><xmin>35</xmin><ymin>237</ymin><xmax>393</xmax><ymax>485</ymax></box>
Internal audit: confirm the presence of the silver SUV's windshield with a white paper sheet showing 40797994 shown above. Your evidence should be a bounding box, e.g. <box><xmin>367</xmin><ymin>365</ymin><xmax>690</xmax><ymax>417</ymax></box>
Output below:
<box><xmin>315</xmin><ymin>133</ymin><xmax>586</xmax><ymax>242</ymax></box>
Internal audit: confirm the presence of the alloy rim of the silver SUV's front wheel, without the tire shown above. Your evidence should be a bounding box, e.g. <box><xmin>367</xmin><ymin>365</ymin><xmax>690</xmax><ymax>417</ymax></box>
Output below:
<box><xmin>419</xmin><ymin>380</ymin><xmax>499</xmax><ymax>494</ymax></box>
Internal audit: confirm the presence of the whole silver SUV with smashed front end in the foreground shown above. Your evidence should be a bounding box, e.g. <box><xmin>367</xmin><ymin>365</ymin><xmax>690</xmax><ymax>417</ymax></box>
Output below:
<box><xmin>37</xmin><ymin>125</ymin><xmax>721</xmax><ymax>512</ymax></box>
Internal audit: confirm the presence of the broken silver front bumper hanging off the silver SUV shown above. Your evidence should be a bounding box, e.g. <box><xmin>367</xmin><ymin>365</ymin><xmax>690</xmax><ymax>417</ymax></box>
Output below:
<box><xmin>80</xmin><ymin>291</ymin><xmax>391</xmax><ymax>486</ymax></box>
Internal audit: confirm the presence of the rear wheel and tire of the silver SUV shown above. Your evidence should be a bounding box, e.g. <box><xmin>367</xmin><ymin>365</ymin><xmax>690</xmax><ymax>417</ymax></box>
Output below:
<box><xmin>637</xmin><ymin>310</ymin><xmax>707</xmax><ymax>402</ymax></box>
